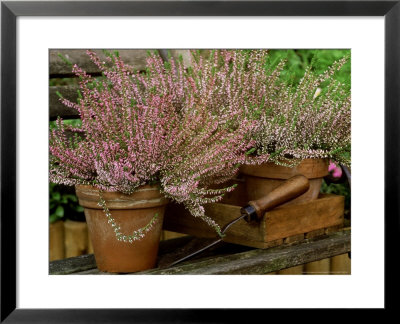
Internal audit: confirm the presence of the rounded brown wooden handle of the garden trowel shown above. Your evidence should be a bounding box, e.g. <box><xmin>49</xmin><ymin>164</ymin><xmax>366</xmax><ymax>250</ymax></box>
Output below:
<box><xmin>242</xmin><ymin>175</ymin><xmax>310</xmax><ymax>221</ymax></box>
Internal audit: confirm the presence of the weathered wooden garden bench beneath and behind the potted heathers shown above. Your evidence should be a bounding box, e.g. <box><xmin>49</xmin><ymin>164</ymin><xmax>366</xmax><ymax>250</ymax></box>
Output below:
<box><xmin>49</xmin><ymin>50</ymin><xmax>351</xmax><ymax>275</ymax></box>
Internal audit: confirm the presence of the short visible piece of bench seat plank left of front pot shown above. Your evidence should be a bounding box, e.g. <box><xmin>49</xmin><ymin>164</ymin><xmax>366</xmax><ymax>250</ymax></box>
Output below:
<box><xmin>49</xmin><ymin>254</ymin><xmax>96</xmax><ymax>275</ymax></box>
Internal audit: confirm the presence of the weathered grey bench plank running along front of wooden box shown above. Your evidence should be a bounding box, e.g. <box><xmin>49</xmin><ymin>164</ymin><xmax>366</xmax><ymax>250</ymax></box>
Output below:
<box><xmin>135</xmin><ymin>231</ymin><xmax>351</xmax><ymax>275</ymax></box>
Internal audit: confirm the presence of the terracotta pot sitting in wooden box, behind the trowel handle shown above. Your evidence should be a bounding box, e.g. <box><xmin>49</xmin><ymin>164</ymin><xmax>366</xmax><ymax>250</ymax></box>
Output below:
<box><xmin>240</xmin><ymin>159</ymin><xmax>328</xmax><ymax>205</ymax></box>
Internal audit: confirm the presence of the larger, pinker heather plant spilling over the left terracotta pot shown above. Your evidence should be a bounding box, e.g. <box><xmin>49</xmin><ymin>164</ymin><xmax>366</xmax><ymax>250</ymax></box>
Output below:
<box><xmin>50</xmin><ymin>51</ymin><xmax>256</xmax><ymax>233</ymax></box>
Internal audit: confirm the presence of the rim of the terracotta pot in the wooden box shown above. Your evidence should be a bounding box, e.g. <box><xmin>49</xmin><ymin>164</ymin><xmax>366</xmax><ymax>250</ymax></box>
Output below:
<box><xmin>240</xmin><ymin>159</ymin><xmax>329</xmax><ymax>179</ymax></box>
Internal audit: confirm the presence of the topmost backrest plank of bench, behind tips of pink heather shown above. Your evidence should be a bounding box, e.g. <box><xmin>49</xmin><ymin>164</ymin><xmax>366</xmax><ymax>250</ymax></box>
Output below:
<box><xmin>50</xmin><ymin>49</ymin><xmax>151</xmax><ymax>77</ymax></box>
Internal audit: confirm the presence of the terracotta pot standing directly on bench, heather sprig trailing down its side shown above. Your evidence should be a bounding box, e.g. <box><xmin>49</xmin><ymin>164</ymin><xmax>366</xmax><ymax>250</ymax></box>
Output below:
<box><xmin>76</xmin><ymin>185</ymin><xmax>168</xmax><ymax>273</ymax></box>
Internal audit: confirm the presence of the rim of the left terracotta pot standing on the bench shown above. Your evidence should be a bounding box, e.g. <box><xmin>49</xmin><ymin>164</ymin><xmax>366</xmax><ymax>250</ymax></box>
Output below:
<box><xmin>75</xmin><ymin>185</ymin><xmax>169</xmax><ymax>209</ymax></box>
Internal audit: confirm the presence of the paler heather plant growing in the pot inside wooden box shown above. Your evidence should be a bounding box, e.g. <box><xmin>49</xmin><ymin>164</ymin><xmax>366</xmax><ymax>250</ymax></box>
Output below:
<box><xmin>254</xmin><ymin>53</ymin><xmax>351</xmax><ymax>166</ymax></box>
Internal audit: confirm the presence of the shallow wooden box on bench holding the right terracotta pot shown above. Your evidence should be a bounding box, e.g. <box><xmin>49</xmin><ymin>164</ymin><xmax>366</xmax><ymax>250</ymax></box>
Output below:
<box><xmin>164</xmin><ymin>180</ymin><xmax>344</xmax><ymax>248</ymax></box>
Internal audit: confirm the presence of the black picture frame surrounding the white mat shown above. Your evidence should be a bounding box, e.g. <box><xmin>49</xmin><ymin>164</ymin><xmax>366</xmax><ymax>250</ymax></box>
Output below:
<box><xmin>0</xmin><ymin>0</ymin><xmax>400</xmax><ymax>323</ymax></box>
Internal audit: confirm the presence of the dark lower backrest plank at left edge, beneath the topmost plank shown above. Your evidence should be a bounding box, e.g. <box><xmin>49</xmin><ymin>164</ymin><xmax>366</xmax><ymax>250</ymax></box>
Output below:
<box><xmin>49</xmin><ymin>85</ymin><xmax>79</xmax><ymax>120</ymax></box>
